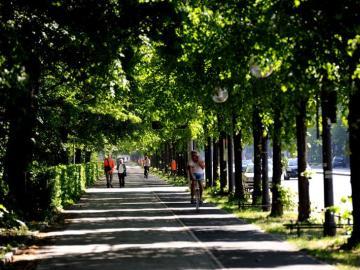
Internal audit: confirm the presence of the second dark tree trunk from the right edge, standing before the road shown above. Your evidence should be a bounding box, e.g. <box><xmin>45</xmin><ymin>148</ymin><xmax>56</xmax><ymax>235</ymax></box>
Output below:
<box><xmin>321</xmin><ymin>89</ymin><xmax>336</xmax><ymax>236</ymax></box>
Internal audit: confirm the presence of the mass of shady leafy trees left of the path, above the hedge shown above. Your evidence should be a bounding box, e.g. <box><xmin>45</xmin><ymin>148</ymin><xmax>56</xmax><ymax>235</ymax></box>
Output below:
<box><xmin>0</xmin><ymin>0</ymin><xmax>177</xmax><ymax>213</ymax></box>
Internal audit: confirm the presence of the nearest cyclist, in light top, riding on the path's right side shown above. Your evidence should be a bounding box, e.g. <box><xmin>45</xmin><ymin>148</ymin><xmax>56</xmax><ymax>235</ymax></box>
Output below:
<box><xmin>188</xmin><ymin>151</ymin><xmax>205</xmax><ymax>203</ymax></box>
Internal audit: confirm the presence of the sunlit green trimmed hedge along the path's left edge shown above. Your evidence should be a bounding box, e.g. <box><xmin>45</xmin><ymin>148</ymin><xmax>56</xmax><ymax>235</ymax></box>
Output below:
<box><xmin>27</xmin><ymin>163</ymin><xmax>103</xmax><ymax>218</ymax></box>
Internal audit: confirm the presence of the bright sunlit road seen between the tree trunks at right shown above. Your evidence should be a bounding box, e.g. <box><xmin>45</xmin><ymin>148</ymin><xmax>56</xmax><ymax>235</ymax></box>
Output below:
<box><xmin>282</xmin><ymin>168</ymin><xmax>352</xmax><ymax>210</ymax></box>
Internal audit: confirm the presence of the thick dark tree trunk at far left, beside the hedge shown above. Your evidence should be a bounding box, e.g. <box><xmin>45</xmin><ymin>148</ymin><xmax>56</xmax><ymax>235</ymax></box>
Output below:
<box><xmin>4</xmin><ymin>57</ymin><xmax>41</xmax><ymax>214</ymax></box>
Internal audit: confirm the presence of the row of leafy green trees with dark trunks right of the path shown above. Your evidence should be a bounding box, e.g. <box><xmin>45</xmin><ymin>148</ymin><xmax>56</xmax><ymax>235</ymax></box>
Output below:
<box><xmin>124</xmin><ymin>1</ymin><xmax>359</xmax><ymax>245</ymax></box>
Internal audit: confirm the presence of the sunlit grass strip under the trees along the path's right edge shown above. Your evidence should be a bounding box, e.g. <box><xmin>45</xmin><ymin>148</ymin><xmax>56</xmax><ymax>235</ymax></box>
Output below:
<box><xmin>204</xmin><ymin>190</ymin><xmax>360</xmax><ymax>270</ymax></box>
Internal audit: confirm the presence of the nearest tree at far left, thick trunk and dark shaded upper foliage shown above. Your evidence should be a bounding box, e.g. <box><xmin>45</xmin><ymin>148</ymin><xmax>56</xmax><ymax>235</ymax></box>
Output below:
<box><xmin>0</xmin><ymin>1</ymin><xmax>180</xmax><ymax>212</ymax></box>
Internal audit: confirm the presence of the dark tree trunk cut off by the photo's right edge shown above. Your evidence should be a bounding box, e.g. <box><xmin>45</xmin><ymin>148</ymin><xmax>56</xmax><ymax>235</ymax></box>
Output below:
<box><xmin>348</xmin><ymin>79</ymin><xmax>360</xmax><ymax>247</ymax></box>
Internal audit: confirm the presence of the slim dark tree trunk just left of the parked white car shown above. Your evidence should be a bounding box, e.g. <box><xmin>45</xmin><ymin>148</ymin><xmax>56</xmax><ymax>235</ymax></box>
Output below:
<box><xmin>234</xmin><ymin>127</ymin><xmax>245</xmax><ymax>200</ymax></box>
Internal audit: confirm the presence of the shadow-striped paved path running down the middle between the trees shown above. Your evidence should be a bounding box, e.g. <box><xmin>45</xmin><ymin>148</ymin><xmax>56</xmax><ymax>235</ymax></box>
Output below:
<box><xmin>18</xmin><ymin>167</ymin><xmax>332</xmax><ymax>270</ymax></box>
